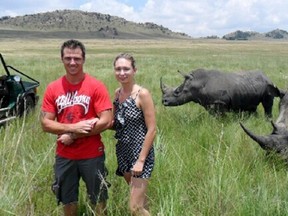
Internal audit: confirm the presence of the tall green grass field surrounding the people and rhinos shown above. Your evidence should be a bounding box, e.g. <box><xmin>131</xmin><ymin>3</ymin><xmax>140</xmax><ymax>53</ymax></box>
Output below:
<box><xmin>0</xmin><ymin>39</ymin><xmax>288</xmax><ymax>216</ymax></box>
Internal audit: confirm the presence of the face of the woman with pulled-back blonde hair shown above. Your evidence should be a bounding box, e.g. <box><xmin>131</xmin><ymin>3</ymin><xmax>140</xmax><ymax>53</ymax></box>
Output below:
<box><xmin>114</xmin><ymin>58</ymin><xmax>136</xmax><ymax>83</ymax></box>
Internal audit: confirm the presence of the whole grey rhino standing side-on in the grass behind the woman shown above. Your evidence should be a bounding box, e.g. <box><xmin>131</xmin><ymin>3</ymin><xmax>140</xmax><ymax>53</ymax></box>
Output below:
<box><xmin>160</xmin><ymin>69</ymin><xmax>277</xmax><ymax>117</ymax></box>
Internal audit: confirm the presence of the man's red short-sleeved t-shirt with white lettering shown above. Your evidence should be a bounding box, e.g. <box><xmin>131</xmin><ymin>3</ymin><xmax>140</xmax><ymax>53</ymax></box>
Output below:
<box><xmin>42</xmin><ymin>74</ymin><xmax>112</xmax><ymax>160</ymax></box>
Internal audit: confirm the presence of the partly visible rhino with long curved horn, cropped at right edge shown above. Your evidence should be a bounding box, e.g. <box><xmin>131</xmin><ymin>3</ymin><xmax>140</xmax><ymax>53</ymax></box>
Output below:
<box><xmin>240</xmin><ymin>90</ymin><xmax>288</xmax><ymax>159</ymax></box>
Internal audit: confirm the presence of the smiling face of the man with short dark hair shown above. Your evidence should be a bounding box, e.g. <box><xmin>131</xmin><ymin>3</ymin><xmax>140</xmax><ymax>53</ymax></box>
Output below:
<box><xmin>62</xmin><ymin>48</ymin><xmax>85</xmax><ymax>76</ymax></box>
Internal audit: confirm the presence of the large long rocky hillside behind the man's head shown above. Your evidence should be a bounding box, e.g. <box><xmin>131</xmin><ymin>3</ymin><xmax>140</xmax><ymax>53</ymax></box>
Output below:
<box><xmin>0</xmin><ymin>10</ymin><xmax>190</xmax><ymax>39</ymax></box>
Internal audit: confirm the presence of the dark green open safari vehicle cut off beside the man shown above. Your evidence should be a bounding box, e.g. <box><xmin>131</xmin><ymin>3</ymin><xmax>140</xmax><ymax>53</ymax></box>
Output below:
<box><xmin>0</xmin><ymin>53</ymin><xmax>40</xmax><ymax>125</ymax></box>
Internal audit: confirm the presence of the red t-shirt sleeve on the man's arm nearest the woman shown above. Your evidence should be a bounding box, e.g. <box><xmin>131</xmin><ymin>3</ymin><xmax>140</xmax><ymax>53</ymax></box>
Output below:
<box><xmin>94</xmin><ymin>82</ymin><xmax>112</xmax><ymax>113</ymax></box>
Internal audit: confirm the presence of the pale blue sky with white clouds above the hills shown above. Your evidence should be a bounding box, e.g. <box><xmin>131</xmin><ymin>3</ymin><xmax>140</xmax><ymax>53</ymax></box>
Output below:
<box><xmin>0</xmin><ymin>0</ymin><xmax>288</xmax><ymax>38</ymax></box>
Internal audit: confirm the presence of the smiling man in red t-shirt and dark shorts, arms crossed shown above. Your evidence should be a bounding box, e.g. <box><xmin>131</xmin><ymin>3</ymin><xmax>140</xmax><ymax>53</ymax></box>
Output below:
<box><xmin>41</xmin><ymin>40</ymin><xmax>113</xmax><ymax>215</ymax></box>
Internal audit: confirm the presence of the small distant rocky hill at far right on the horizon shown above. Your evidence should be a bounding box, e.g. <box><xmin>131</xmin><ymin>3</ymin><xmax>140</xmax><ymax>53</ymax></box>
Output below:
<box><xmin>223</xmin><ymin>29</ymin><xmax>288</xmax><ymax>40</ymax></box>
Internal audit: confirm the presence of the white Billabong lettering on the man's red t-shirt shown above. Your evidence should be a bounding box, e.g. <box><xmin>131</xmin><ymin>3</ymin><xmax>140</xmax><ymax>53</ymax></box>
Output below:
<box><xmin>56</xmin><ymin>91</ymin><xmax>91</xmax><ymax>114</ymax></box>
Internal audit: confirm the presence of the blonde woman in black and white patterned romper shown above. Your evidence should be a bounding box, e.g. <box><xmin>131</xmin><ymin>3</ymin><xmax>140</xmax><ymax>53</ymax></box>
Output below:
<box><xmin>114</xmin><ymin>53</ymin><xmax>156</xmax><ymax>215</ymax></box>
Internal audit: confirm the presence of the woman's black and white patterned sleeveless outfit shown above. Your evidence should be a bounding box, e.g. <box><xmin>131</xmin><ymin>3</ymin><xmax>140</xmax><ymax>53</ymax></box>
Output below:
<box><xmin>114</xmin><ymin>89</ymin><xmax>154</xmax><ymax>178</ymax></box>
